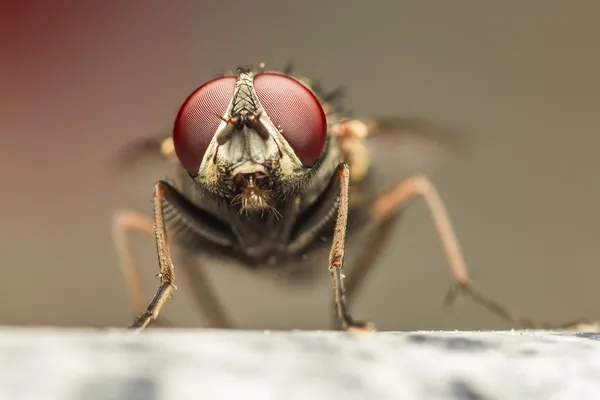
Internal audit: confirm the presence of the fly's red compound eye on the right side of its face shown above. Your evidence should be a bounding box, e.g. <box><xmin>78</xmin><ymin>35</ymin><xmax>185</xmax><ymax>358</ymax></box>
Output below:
<box><xmin>254</xmin><ymin>73</ymin><xmax>327</xmax><ymax>166</ymax></box>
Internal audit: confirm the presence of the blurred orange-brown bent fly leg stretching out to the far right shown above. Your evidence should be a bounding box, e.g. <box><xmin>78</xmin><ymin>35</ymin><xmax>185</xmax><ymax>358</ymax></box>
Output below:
<box><xmin>347</xmin><ymin>175</ymin><xmax>600</xmax><ymax>331</ymax></box>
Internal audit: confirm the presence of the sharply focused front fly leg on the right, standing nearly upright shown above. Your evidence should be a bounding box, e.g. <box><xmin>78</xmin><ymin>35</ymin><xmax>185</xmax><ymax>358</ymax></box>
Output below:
<box><xmin>329</xmin><ymin>164</ymin><xmax>371</xmax><ymax>331</ymax></box>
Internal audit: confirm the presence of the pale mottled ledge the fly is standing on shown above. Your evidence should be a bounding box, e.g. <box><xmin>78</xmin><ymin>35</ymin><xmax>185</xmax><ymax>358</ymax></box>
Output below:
<box><xmin>0</xmin><ymin>329</ymin><xmax>600</xmax><ymax>400</ymax></box>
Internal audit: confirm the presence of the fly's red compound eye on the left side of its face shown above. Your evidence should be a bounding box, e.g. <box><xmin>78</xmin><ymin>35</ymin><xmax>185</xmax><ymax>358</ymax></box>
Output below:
<box><xmin>173</xmin><ymin>77</ymin><xmax>236</xmax><ymax>176</ymax></box>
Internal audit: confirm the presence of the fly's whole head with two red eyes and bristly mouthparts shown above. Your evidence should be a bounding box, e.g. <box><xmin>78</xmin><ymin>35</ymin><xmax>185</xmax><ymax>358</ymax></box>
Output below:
<box><xmin>173</xmin><ymin>69</ymin><xmax>328</xmax><ymax>213</ymax></box>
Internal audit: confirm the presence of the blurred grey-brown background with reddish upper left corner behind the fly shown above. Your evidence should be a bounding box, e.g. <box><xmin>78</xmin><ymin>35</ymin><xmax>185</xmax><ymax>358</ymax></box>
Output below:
<box><xmin>0</xmin><ymin>0</ymin><xmax>600</xmax><ymax>329</ymax></box>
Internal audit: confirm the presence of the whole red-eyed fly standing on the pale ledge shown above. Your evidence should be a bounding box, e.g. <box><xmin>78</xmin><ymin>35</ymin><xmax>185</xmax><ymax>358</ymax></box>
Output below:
<box><xmin>113</xmin><ymin>64</ymin><xmax>596</xmax><ymax>331</ymax></box>
